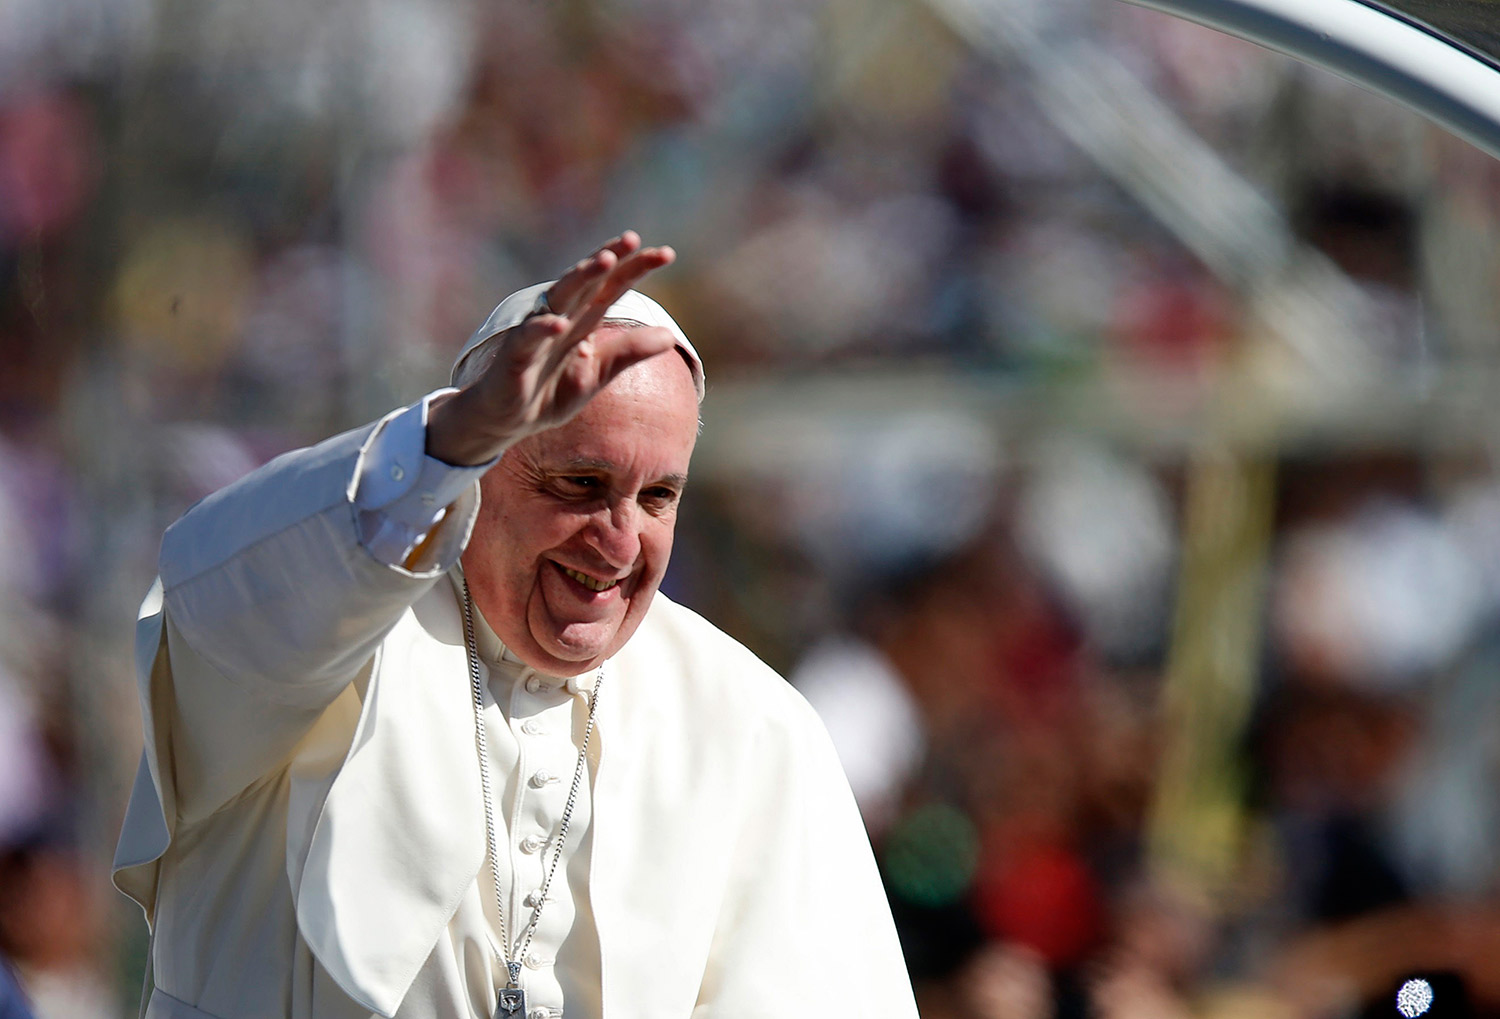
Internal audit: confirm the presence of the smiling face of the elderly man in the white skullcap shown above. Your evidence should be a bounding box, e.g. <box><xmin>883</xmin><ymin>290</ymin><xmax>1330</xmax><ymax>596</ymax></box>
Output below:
<box><xmin>464</xmin><ymin>345</ymin><xmax>698</xmax><ymax>675</ymax></box>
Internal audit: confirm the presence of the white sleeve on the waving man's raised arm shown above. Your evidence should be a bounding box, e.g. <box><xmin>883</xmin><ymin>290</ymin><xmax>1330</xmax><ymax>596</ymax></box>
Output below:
<box><xmin>150</xmin><ymin>404</ymin><xmax>479</xmax><ymax>819</ymax></box>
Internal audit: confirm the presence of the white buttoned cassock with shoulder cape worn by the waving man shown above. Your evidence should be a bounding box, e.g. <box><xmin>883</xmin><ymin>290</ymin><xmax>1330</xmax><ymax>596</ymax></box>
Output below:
<box><xmin>116</xmin><ymin>387</ymin><xmax>917</xmax><ymax>1019</ymax></box>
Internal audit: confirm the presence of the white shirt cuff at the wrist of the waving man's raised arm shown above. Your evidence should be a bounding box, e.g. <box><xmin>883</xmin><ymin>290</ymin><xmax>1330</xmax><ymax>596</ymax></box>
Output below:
<box><xmin>354</xmin><ymin>389</ymin><xmax>498</xmax><ymax>566</ymax></box>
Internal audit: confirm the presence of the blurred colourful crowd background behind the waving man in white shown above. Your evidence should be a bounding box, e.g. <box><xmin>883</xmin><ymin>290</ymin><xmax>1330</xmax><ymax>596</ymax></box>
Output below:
<box><xmin>0</xmin><ymin>0</ymin><xmax>1500</xmax><ymax>1019</ymax></box>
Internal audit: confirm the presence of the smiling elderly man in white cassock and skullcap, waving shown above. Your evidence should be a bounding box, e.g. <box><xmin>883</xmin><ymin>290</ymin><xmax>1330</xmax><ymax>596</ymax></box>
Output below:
<box><xmin>116</xmin><ymin>233</ymin><xmax>915</xmax><ymax>1019</ymax></box>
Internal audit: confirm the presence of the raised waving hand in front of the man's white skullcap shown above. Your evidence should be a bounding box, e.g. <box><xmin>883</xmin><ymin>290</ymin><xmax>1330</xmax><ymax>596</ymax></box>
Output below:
<box><xmin>428</xmin><ymin>230</ymin><xmax>677</xmax><ymax>464</ymax></box>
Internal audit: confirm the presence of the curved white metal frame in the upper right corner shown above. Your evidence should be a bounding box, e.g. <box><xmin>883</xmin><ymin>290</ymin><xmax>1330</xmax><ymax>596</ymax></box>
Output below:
<box><xmin>1127</xmin><ymin>0</ymin><xmax>1500</xmax><ymax>159</ymax></box>
